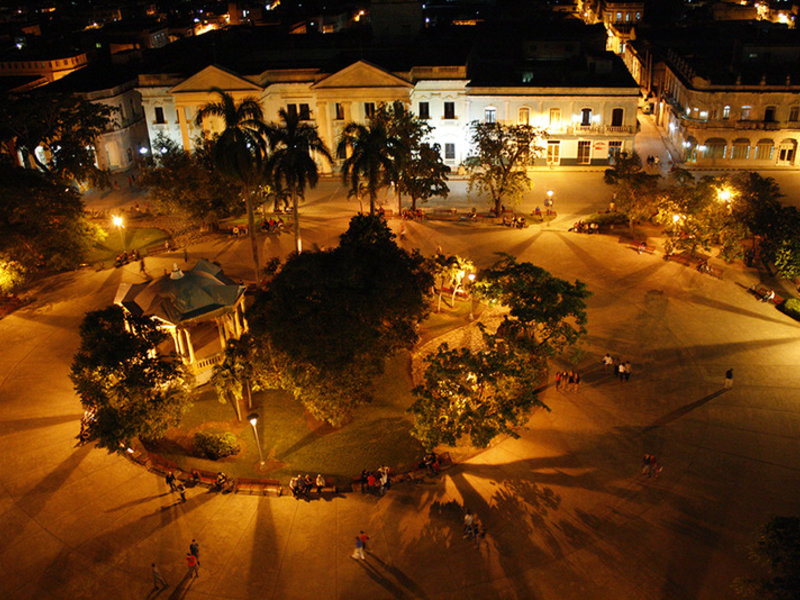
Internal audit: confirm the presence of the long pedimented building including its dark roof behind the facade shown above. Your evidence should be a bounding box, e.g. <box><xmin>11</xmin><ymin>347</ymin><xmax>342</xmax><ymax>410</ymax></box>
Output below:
<box><xmin>137</xmin><ymin>25</ymin><xmax>639</xmax><ymax>172</ymax></box>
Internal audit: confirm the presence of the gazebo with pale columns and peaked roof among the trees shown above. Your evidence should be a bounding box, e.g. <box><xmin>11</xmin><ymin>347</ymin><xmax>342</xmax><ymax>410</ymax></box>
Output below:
<box><xmin>114</xmin><ymin>260</ymin><xmax>248</xmax><ymax>385</ymax></box>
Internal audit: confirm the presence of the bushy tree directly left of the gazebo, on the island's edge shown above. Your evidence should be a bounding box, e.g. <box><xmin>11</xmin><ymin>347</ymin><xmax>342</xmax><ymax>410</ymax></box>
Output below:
<box><xmin>70</xmin><ymin>306</ymin><xmax>192</xmax><ymax>452</ymax></box>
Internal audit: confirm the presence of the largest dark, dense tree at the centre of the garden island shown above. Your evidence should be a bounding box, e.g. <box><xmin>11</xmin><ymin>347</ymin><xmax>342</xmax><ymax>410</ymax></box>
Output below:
<box><xmin>248</xmin><ymin>215</ymin><xmax>432</xmax><ymax>424</ymax></box>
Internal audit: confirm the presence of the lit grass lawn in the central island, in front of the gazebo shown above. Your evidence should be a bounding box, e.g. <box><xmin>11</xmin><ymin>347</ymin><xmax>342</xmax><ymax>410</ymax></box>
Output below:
<box><xmin>149</xmin><ymin>308</ymin><xmax>476</xmax><ymax>485</ymax></box>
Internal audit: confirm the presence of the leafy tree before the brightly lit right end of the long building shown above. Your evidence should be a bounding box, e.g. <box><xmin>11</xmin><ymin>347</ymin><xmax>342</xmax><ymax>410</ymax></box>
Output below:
<box><xmin>464</xmin><ymin>121</ymin><xmax>546</xmax><ymax>215</ymax></box>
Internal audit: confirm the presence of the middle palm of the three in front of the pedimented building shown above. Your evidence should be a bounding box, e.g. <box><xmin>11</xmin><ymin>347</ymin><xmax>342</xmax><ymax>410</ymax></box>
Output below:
<box><xmin>267</xmin><ymin>109</ymin><xmax>333</xmax><ymax>254</ymax></box>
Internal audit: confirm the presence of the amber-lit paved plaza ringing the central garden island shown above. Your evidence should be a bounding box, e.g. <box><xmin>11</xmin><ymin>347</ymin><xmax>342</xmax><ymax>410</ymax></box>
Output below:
<box><xmin>0</xmin><ymin>189</ymin><xmax>800</xmax><ymax>600</ymax></box>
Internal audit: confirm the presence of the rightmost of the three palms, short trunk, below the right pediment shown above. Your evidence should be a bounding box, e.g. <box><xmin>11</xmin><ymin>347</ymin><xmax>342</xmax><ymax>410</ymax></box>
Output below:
<box><xmin>337</xmin><ymin>120</ymin><xmax>397</xmax><ymax>215</ymax></box>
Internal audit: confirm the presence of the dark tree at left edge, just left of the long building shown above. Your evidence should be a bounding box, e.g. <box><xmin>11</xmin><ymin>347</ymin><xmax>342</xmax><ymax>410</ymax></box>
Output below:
<box><xmin>0</xmin><ymin>92</ymin><xmax>117</xmax><ymax>186</ymax></box>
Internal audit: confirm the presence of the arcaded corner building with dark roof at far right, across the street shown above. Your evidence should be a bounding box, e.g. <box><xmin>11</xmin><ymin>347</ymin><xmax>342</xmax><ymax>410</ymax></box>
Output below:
<box><xmin>624</xmin><ymin>21</ymin><xmax>800</xmax><ymax>169</ymax></box>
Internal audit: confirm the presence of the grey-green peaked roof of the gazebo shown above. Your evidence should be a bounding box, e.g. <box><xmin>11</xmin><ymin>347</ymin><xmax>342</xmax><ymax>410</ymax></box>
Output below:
<box><xmin>114</xmin><ymin>260</ymin><xmax>246</xmax><ymax>325</ymax></box>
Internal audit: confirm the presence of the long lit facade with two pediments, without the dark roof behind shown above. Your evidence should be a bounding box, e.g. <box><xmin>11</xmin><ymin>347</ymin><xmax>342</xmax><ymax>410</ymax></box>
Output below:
<box><xmin>137</xmin><ymin>55</ymin><xmax>639</xmax><ymax>171</ymax></box>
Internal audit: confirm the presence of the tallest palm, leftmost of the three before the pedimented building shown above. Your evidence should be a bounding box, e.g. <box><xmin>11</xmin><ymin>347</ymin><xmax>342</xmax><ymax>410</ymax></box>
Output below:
<box><xmin>196</xmin><ymin>88</ymin><xmax>267</xmax><ymax>283</ymax></box>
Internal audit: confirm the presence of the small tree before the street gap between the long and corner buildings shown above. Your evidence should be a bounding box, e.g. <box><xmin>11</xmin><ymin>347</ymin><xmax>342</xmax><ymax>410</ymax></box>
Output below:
<box><xmin>603</xmin><ymin>152</ymin><xmax>661</xmax><ymax>227</ymax></box>
